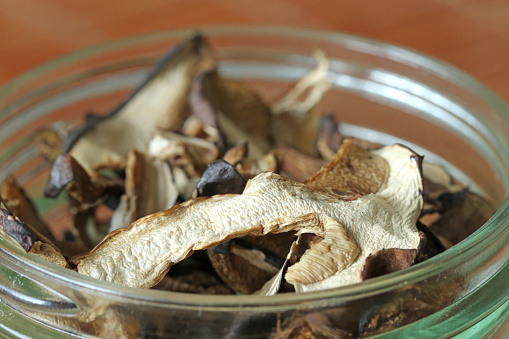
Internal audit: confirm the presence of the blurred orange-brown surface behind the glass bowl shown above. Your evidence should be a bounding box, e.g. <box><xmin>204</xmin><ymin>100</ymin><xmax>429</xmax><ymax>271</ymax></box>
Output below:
<box><xmin>0</xmin><ymin>0</ymin><xmax>509</xmax><ymax>338</ymax></box>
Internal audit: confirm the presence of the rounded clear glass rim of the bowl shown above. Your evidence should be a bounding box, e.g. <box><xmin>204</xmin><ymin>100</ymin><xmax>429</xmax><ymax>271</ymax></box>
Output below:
<box><xmin>0</xmin><ymin>26</ymin><xmax>509</xmax><ymax>309</ymax></box>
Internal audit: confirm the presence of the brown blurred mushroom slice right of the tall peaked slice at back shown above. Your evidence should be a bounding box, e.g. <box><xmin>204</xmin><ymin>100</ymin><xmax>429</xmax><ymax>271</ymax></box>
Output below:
<box><xmin>190</xmin><ymin>71</ymin><xmax>272</xmax><ymax>158</ymax></box>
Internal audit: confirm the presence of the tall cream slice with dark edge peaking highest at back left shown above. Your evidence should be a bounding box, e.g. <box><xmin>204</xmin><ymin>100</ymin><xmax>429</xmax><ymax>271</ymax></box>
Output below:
<box><xmin>64</xmin><ymin>35</ymin><xmax>214</xmax><ymax>177</ymax></box>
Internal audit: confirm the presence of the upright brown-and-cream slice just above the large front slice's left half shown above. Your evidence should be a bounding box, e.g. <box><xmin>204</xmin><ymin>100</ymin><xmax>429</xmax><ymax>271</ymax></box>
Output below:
<box><xmin>110</xmin><ymin>150</ymin><xmax>179</xmax><ymax>232</ymax></box>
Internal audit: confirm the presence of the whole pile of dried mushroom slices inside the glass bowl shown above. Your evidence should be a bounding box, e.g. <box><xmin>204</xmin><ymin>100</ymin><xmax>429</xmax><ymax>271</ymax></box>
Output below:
<box><xmin>0</xmin><ymin>35</ymin><xmax>493</xmax><ymax>295</ymax></box>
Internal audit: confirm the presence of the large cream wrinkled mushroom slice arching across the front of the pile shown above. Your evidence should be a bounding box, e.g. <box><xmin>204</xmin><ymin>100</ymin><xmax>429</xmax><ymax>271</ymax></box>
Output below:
<box><xmin>70</xmin><ymin>145</ymin><xmax>422</xmax><ymax>292</ymax></box>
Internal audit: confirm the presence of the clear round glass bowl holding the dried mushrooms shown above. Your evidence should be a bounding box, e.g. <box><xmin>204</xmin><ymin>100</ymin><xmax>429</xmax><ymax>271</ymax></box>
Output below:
<box><xmin>0</xmin><ymin>27</ymin><xmax>509</xmax><ymax>338</ymax></box>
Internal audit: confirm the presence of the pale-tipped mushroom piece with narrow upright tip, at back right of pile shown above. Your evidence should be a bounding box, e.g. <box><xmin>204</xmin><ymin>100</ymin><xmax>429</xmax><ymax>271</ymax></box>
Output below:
<box><xmin>270</xmin><ymin>51</ymin><xmax>331</xmax><ymax>155</ymax></box>
